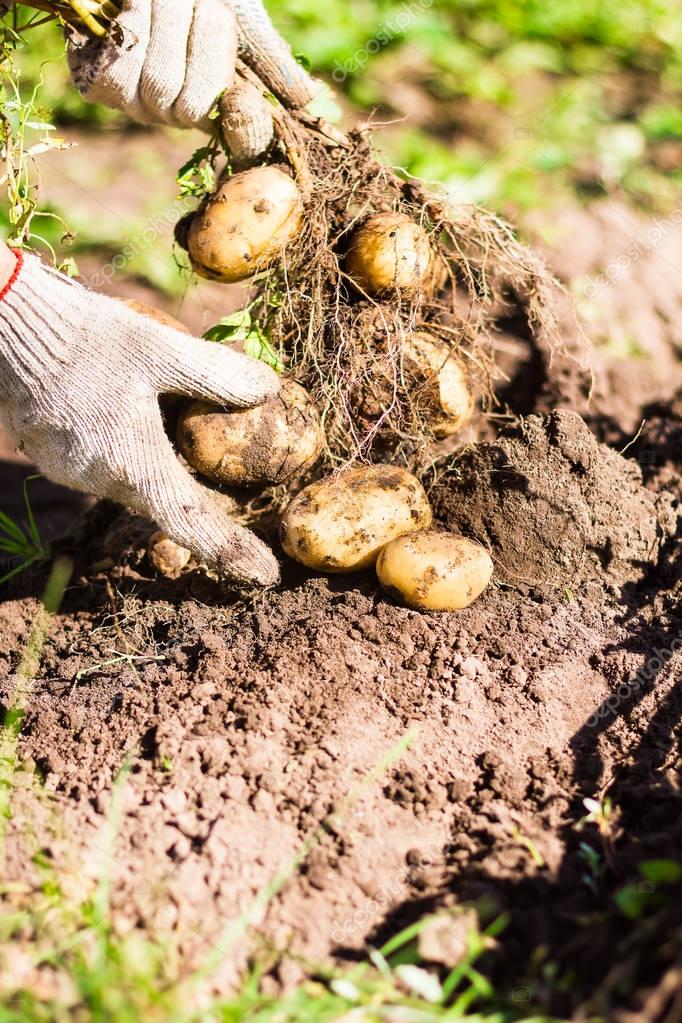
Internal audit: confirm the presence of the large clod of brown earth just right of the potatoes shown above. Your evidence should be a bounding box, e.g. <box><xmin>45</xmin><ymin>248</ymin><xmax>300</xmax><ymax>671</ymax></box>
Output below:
<box><xmin>429</xmin><ymin>412</ymin><xmax>665</xmax><ymax>588</ymax></box>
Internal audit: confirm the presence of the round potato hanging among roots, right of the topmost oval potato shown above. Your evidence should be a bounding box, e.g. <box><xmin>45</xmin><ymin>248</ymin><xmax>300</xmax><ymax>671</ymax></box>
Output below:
<box><xmin>346</xmin><ymin>213</ymin><xmax>445</xmax><ymax>298</ymax></box>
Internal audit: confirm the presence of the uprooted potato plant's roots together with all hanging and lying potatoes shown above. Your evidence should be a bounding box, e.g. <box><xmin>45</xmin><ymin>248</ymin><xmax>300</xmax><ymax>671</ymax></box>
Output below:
<box><xmin>6</xmin><ymin>0</ymin><xmax>557</xmax><ymax>609</ymax></box>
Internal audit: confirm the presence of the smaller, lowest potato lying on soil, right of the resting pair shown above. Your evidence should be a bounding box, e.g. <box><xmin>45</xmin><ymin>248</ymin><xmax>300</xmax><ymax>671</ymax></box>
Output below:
<box><xmin>376</xmin><ymin>529</ymin><xmax>493</xmax><ymax>611</ymax></box>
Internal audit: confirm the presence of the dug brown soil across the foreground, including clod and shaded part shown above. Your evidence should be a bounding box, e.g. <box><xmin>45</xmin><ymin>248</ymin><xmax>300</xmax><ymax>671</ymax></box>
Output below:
<box><xmin>0</xmin><ymin>197</ymin><xmax>682</xmax><ymax>1023</ymax></box>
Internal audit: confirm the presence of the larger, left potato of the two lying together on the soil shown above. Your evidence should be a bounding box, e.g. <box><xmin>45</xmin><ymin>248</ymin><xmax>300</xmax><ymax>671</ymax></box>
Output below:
<box><xmin>279</xmin><ymin>465</ymin><xmax>431</xmax><ymax>572</ymax></box>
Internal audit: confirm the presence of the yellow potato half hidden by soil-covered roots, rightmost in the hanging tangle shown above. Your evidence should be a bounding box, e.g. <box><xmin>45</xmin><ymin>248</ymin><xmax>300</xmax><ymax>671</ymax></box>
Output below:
<box><xmin>403</xmin><ymin>330</ymin><xmax>473</xmax><ymax>437</ymax></box>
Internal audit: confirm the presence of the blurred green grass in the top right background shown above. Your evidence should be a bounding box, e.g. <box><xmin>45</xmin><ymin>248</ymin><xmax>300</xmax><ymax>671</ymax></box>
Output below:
<box><xmin>269</xmin><ymin>0</ymin><xmax>682</xmax><ymax>213</ymax></box>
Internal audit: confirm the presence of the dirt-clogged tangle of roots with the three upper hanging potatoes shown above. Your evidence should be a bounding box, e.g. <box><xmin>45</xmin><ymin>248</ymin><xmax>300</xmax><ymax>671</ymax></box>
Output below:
<box><xmin>176</xmin><ymin>64</ymin><xmax>557</xmax><ymax>472</ymax></box>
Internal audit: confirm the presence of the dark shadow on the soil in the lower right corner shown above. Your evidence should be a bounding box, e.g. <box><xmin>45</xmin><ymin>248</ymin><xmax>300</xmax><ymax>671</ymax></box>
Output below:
<box><xmin>359</xmin><ymin>501</ymin><xmax>682</xmax><ymax>1023</ymax></box>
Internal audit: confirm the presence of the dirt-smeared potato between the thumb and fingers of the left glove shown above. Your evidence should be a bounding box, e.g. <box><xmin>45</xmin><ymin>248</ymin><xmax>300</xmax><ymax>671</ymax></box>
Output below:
<box><xmin>177</xmin><ymin>380</ymin><xmax>324</xmax><ymax>487</ymax></box>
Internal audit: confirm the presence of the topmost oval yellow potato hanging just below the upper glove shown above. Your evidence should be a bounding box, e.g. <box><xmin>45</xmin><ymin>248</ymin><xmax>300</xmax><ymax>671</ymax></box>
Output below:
<box><xmin>187</xmin><ymin>167</ymin><xmax>303</xmax><ymax>281</ymax></box>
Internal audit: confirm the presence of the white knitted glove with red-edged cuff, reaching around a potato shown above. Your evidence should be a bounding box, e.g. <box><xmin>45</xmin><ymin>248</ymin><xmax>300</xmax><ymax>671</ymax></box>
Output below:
<box><xmin>0</xmin><ymin>255</ymin><xmax>279</xmax><ymax>584</ymax></box>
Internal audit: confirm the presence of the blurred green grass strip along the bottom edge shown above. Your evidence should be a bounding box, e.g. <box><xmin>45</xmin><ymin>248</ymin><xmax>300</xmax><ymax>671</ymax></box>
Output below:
<box><xmin>0</xmin><ymin>881</ymin><xmax>535</xmax><ymax>1023</ymax></box>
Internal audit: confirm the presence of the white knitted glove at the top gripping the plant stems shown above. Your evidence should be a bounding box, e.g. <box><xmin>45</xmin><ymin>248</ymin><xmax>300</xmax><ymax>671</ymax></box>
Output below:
<box><xmin>69</xmin><ymin>0</ymin><xmax>319</xmax><ymax>137</ymax></box>
